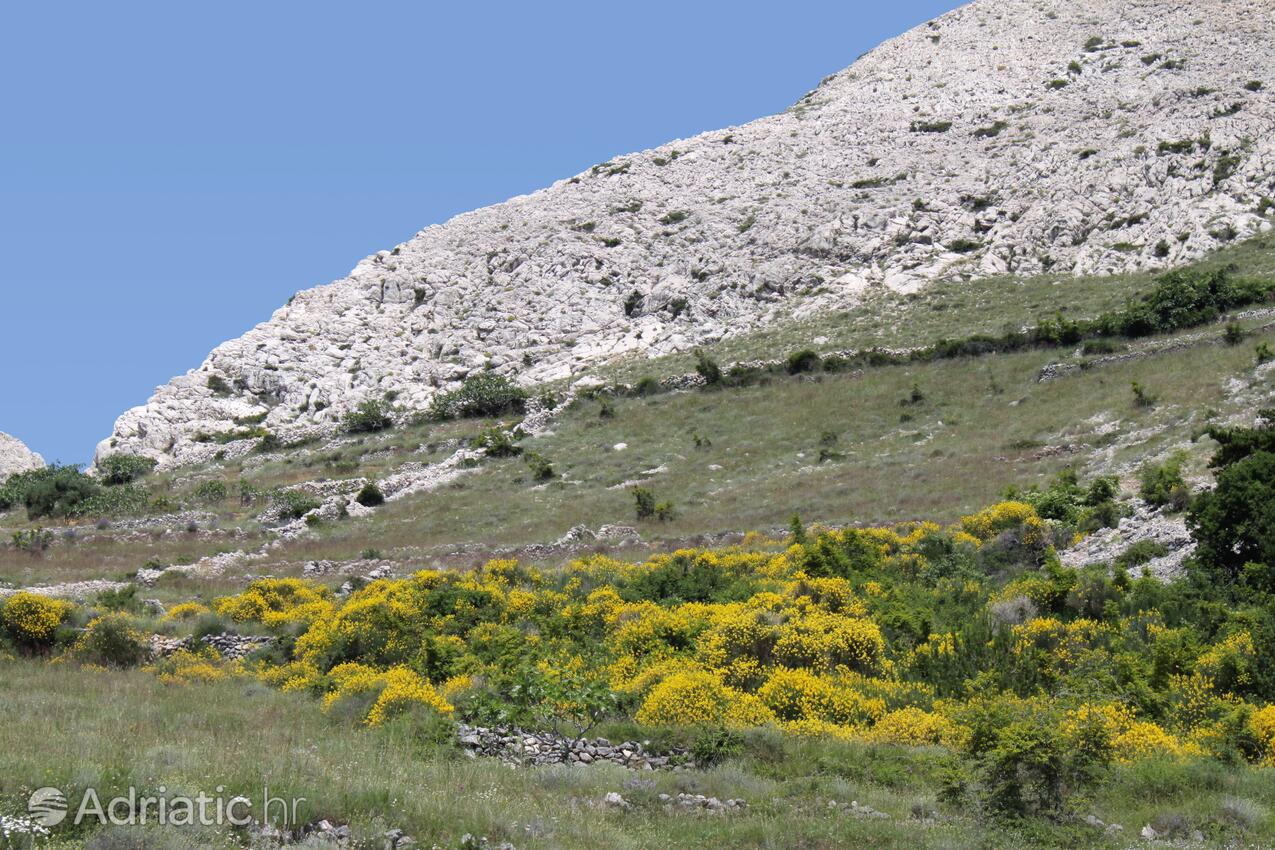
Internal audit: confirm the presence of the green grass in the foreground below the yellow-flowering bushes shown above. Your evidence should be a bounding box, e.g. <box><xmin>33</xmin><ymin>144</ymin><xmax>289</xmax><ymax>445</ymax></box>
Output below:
<box><xmin>0</xmin><ymin>661</ymin><xmax>1275</xmax><ymax>850</ymax></box>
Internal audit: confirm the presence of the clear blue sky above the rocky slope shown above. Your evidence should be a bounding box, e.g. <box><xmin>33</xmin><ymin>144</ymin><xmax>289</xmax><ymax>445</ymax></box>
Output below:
<box><xmin>0</xmin><ymin>0</ymin><xmax>960</xmax><ymax>463</ymax></box>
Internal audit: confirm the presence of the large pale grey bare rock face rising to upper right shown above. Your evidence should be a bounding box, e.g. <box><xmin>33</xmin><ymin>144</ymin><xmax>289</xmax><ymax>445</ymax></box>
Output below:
<box><xmin>99</xmin><ymin>0</ymin><xmax>1275</xmax><ymax>464</ymax></box>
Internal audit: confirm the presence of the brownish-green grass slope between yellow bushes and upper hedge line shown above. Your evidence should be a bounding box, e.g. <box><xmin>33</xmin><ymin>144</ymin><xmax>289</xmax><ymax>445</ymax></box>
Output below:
<box><xmin>9</xmin><ymin>320</ymin><xmax>1275</xmax><ymax>585</ymax></box>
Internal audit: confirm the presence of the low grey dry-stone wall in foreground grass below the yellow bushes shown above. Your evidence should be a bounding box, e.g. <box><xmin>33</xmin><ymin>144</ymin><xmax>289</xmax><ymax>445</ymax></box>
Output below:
<box><xmin>458</xmin><ymin>725</ymin><xmax>687</xmax><ymax>770</ymax></box>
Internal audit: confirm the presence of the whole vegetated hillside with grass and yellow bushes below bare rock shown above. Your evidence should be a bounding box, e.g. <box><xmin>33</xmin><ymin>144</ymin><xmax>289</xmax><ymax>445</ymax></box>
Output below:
<box><xmin>0</xmin><ymin>234</ymin><xmax>1275</xmax><ymax>850</ymax></box>
